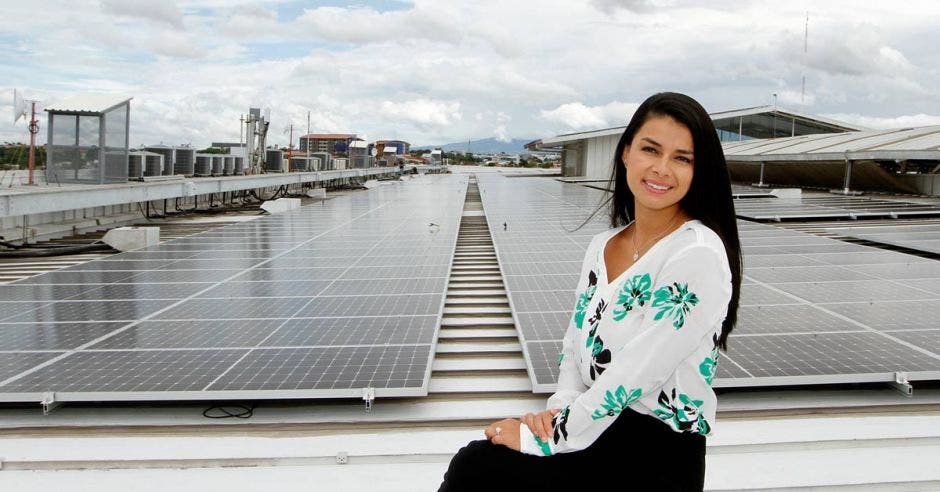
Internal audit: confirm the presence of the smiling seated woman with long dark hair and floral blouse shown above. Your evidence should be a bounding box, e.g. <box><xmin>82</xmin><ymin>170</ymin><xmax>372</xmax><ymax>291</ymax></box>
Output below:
<box><xmin>441</xmin><ymin>93</ymin><xmax>741</xmax><ymax>492</ymax></box>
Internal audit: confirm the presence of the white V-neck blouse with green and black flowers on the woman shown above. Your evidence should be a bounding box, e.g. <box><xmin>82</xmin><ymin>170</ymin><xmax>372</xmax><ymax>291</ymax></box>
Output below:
<box><xmin>520</xmin><ymin>220</ymin><xmax>731</xmax><ymax>456</ymax></box>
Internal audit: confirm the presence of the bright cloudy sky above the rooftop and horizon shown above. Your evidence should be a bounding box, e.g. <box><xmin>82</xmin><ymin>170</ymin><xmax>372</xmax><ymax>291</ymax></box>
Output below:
<box><xmin>0</xmin><ymin>0</ymin><xmax>940</xmax><ymax>147</ymax></box>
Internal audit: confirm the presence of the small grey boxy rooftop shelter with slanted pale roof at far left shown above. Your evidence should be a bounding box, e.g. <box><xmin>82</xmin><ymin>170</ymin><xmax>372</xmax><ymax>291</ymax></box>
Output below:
<box><xmin>45</xmin><ymin>94</ymin><xmax>131</xmax><ymax>184</ymax></box>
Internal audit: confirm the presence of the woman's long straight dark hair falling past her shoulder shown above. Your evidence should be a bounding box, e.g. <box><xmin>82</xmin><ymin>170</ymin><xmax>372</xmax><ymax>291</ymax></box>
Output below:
<box><xmin>610</xmin><ymin>92</ymin><xmax>742</xmax><ymax>350</ymax></box>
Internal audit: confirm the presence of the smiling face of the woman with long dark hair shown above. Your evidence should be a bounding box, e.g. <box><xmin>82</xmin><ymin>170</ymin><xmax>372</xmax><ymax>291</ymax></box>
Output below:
<box><xmin>623</xmin><ymin>116</ymin><xmax>695</xmax><ymax>214</ymax></box>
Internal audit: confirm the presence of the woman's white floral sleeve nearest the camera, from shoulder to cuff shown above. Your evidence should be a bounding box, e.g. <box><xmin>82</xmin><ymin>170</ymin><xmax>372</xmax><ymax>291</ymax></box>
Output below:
<box><xmin>521</xmin><ymin>244</ymin><xmax>731</xmax><ymax>456</ymax></box>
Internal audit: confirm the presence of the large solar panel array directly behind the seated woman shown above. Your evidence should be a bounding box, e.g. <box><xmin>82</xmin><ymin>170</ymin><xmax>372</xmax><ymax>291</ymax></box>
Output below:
<box><xmin>479</xmin><ymin>175</ymin><xmax>940</xmax><ymax>392</ymax></box>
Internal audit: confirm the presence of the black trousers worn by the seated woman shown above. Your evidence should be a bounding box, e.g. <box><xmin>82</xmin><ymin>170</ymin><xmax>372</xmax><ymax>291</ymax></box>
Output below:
<box><xmin>438</xmin><ymin>409</ymin><xmax>705</xmax><ymax>492</ymax></box>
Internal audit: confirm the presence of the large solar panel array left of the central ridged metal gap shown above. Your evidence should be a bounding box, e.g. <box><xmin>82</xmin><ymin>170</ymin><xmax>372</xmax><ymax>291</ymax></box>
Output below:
<box><xmin>0</xmin><ymin>175</ymin><xmax>466</xmax><ymax>401</ymax></box>
